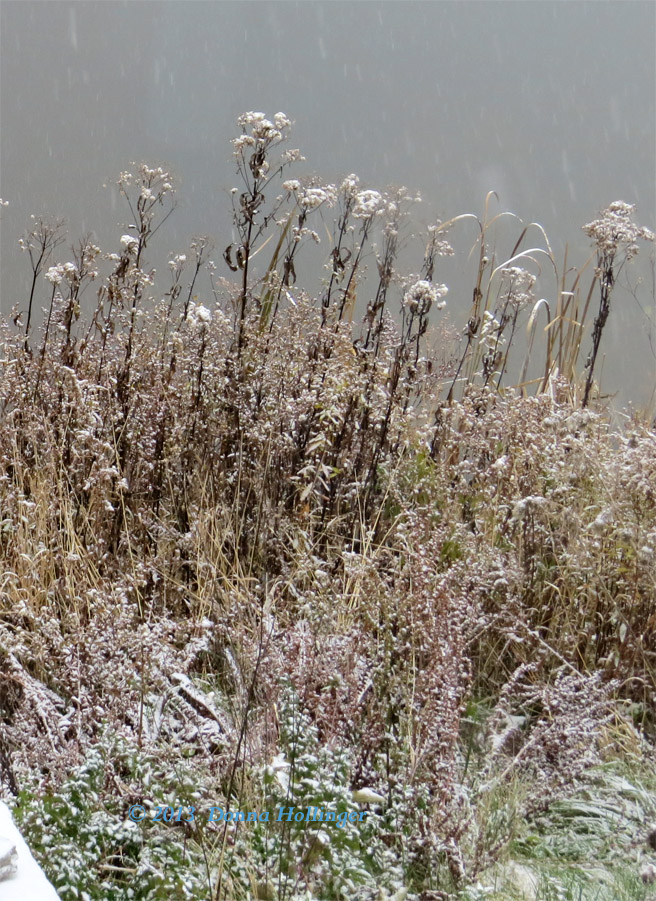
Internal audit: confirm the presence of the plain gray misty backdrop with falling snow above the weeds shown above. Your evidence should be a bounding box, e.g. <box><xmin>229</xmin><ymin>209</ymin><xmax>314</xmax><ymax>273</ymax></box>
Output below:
<box><xmin>0</xmin><ymin>0</ymin><xmax>656</xmax><ymax>404</ymax></box>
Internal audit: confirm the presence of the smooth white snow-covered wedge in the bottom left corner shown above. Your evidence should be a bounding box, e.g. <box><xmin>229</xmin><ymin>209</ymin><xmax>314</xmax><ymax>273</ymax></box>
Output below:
<box><xmin>0</xmin><ymin>801</ymin><xmax>59</xmax><ymax>901</ymax></box>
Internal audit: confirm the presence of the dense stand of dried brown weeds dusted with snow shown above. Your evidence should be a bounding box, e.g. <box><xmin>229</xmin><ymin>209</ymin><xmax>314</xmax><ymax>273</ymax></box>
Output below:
<box><xmin>0</xmin><ymin>112</ymin><xmax>656</xmax><ymax>901</ymax></box>
